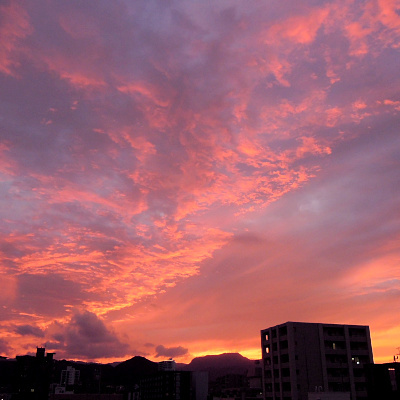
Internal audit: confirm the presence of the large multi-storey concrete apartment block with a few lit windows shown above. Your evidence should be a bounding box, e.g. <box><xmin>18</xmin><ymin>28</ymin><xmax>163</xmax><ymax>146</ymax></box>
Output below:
<box><xmin>261</xmin><ymin>322</ymin><xmax>373</xmax><ymax>400</ymax></box>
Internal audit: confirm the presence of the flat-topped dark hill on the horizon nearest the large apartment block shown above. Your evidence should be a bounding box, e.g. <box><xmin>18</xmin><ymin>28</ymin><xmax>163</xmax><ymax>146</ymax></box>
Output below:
<box><xmin>177</xmin><ymin>353</ymin><xmax>254</xmax><ymax>381</ymax></box>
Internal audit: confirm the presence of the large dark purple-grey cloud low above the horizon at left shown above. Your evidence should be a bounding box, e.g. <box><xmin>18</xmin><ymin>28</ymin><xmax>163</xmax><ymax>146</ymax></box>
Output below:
<box><xmin>47</xmin><ymin>311</ymin><xmax>130</xmax><ymax>360</ymax></box>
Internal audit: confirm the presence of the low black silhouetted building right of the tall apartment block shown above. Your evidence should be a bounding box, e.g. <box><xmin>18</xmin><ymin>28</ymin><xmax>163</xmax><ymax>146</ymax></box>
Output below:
<box><xmin>366</xmin><ymin>362</ymin><xmax>400</xmax><ymax>400</ymax></box>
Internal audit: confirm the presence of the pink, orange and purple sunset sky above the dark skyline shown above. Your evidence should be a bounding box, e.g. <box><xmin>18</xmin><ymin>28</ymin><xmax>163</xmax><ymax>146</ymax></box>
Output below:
<box><xmin>0</xmin><ymin>0</ymin><xmax>400</xmax><ymax>362</ymax></box>
